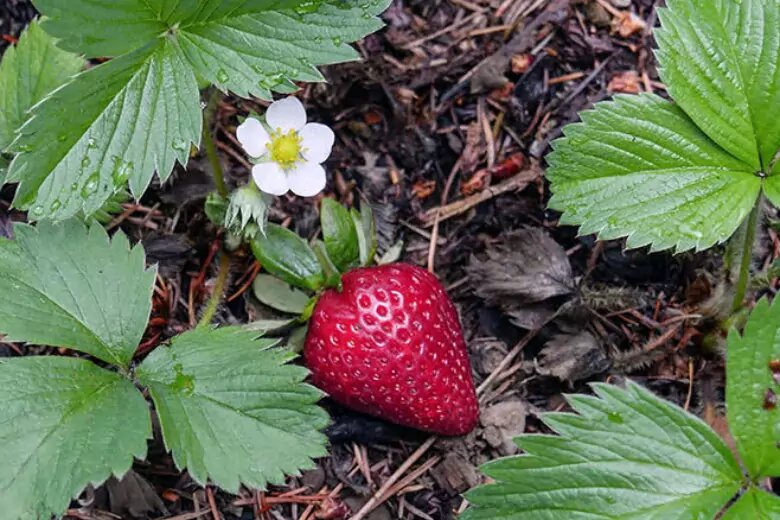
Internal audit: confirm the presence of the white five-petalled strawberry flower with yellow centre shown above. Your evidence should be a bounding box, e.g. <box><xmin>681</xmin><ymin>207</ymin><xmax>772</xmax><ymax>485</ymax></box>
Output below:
<box><xmin>236</xmin><ymin>97</ymin><xmax>336</xmax><ymax>197</ymax></box>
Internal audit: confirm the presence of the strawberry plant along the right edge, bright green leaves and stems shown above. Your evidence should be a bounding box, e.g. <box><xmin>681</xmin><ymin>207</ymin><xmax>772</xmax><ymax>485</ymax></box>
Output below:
<box><xmin>463</xmin><ymin>0</ymin><xmax>780</xmax><ymax>520</ymax></box>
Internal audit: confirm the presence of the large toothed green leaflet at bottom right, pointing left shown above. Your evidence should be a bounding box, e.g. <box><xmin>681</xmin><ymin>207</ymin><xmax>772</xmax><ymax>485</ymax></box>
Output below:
<box><xmin>461</xmin><ymin>382</ymin><xmax>742</xmax><ymax>520</ymax></box>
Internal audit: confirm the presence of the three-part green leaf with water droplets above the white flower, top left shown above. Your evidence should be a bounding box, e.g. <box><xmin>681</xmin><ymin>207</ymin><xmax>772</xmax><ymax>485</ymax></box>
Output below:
<box><xmin>19</xmin><ymin>0</ymin><xmax>389</xmax><ymax>220</ymax></box>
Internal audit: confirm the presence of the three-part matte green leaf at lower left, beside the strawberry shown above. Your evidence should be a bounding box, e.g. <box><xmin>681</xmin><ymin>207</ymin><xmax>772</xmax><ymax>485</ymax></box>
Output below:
<box><xmin>0</xmin><ymin>221</ymin><xmax>328</xmax><ymax>519</ymax></box>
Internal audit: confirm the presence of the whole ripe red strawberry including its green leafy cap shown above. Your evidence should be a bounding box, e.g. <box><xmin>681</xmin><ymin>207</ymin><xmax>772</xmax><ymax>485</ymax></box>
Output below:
<box><xmin>252</xmin><ymin>199</ymin><xmax>479</xmax><ymax>435</ymax></box>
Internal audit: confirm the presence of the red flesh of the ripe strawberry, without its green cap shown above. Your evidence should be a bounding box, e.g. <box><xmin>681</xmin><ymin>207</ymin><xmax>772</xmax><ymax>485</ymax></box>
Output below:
<box><xmin>304</xmin><ymin>264</ymin><xmax>479</xmax><ymax>435</ymax></box>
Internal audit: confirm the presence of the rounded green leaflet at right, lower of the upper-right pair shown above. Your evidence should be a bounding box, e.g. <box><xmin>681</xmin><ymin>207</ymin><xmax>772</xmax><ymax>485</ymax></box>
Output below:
<box><xmin>547</xmin><ymin>94</ymin><xmax>761</xmax><ymax>251</ymax></box>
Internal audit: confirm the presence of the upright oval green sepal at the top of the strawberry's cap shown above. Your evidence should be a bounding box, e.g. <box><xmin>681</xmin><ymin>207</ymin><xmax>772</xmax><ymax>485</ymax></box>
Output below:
<box><xmin>320</xmin><ymin>198</ymin><xmax>360</xmax><ymax>273</ymax></box>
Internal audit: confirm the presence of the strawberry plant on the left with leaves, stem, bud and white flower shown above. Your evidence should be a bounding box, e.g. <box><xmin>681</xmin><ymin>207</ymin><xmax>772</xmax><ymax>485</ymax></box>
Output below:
<box><xmin>0</xmin><ymin>0</ymin><xmax>388</xmax><ymax>520</ymax></box>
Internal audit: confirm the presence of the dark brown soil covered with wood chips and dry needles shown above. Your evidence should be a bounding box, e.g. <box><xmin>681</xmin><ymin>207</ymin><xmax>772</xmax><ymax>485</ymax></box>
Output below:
<box><xmin>0</xmin><ymin>0</ymin><xmax>778</xmax><ymax>520</ymax></box>
